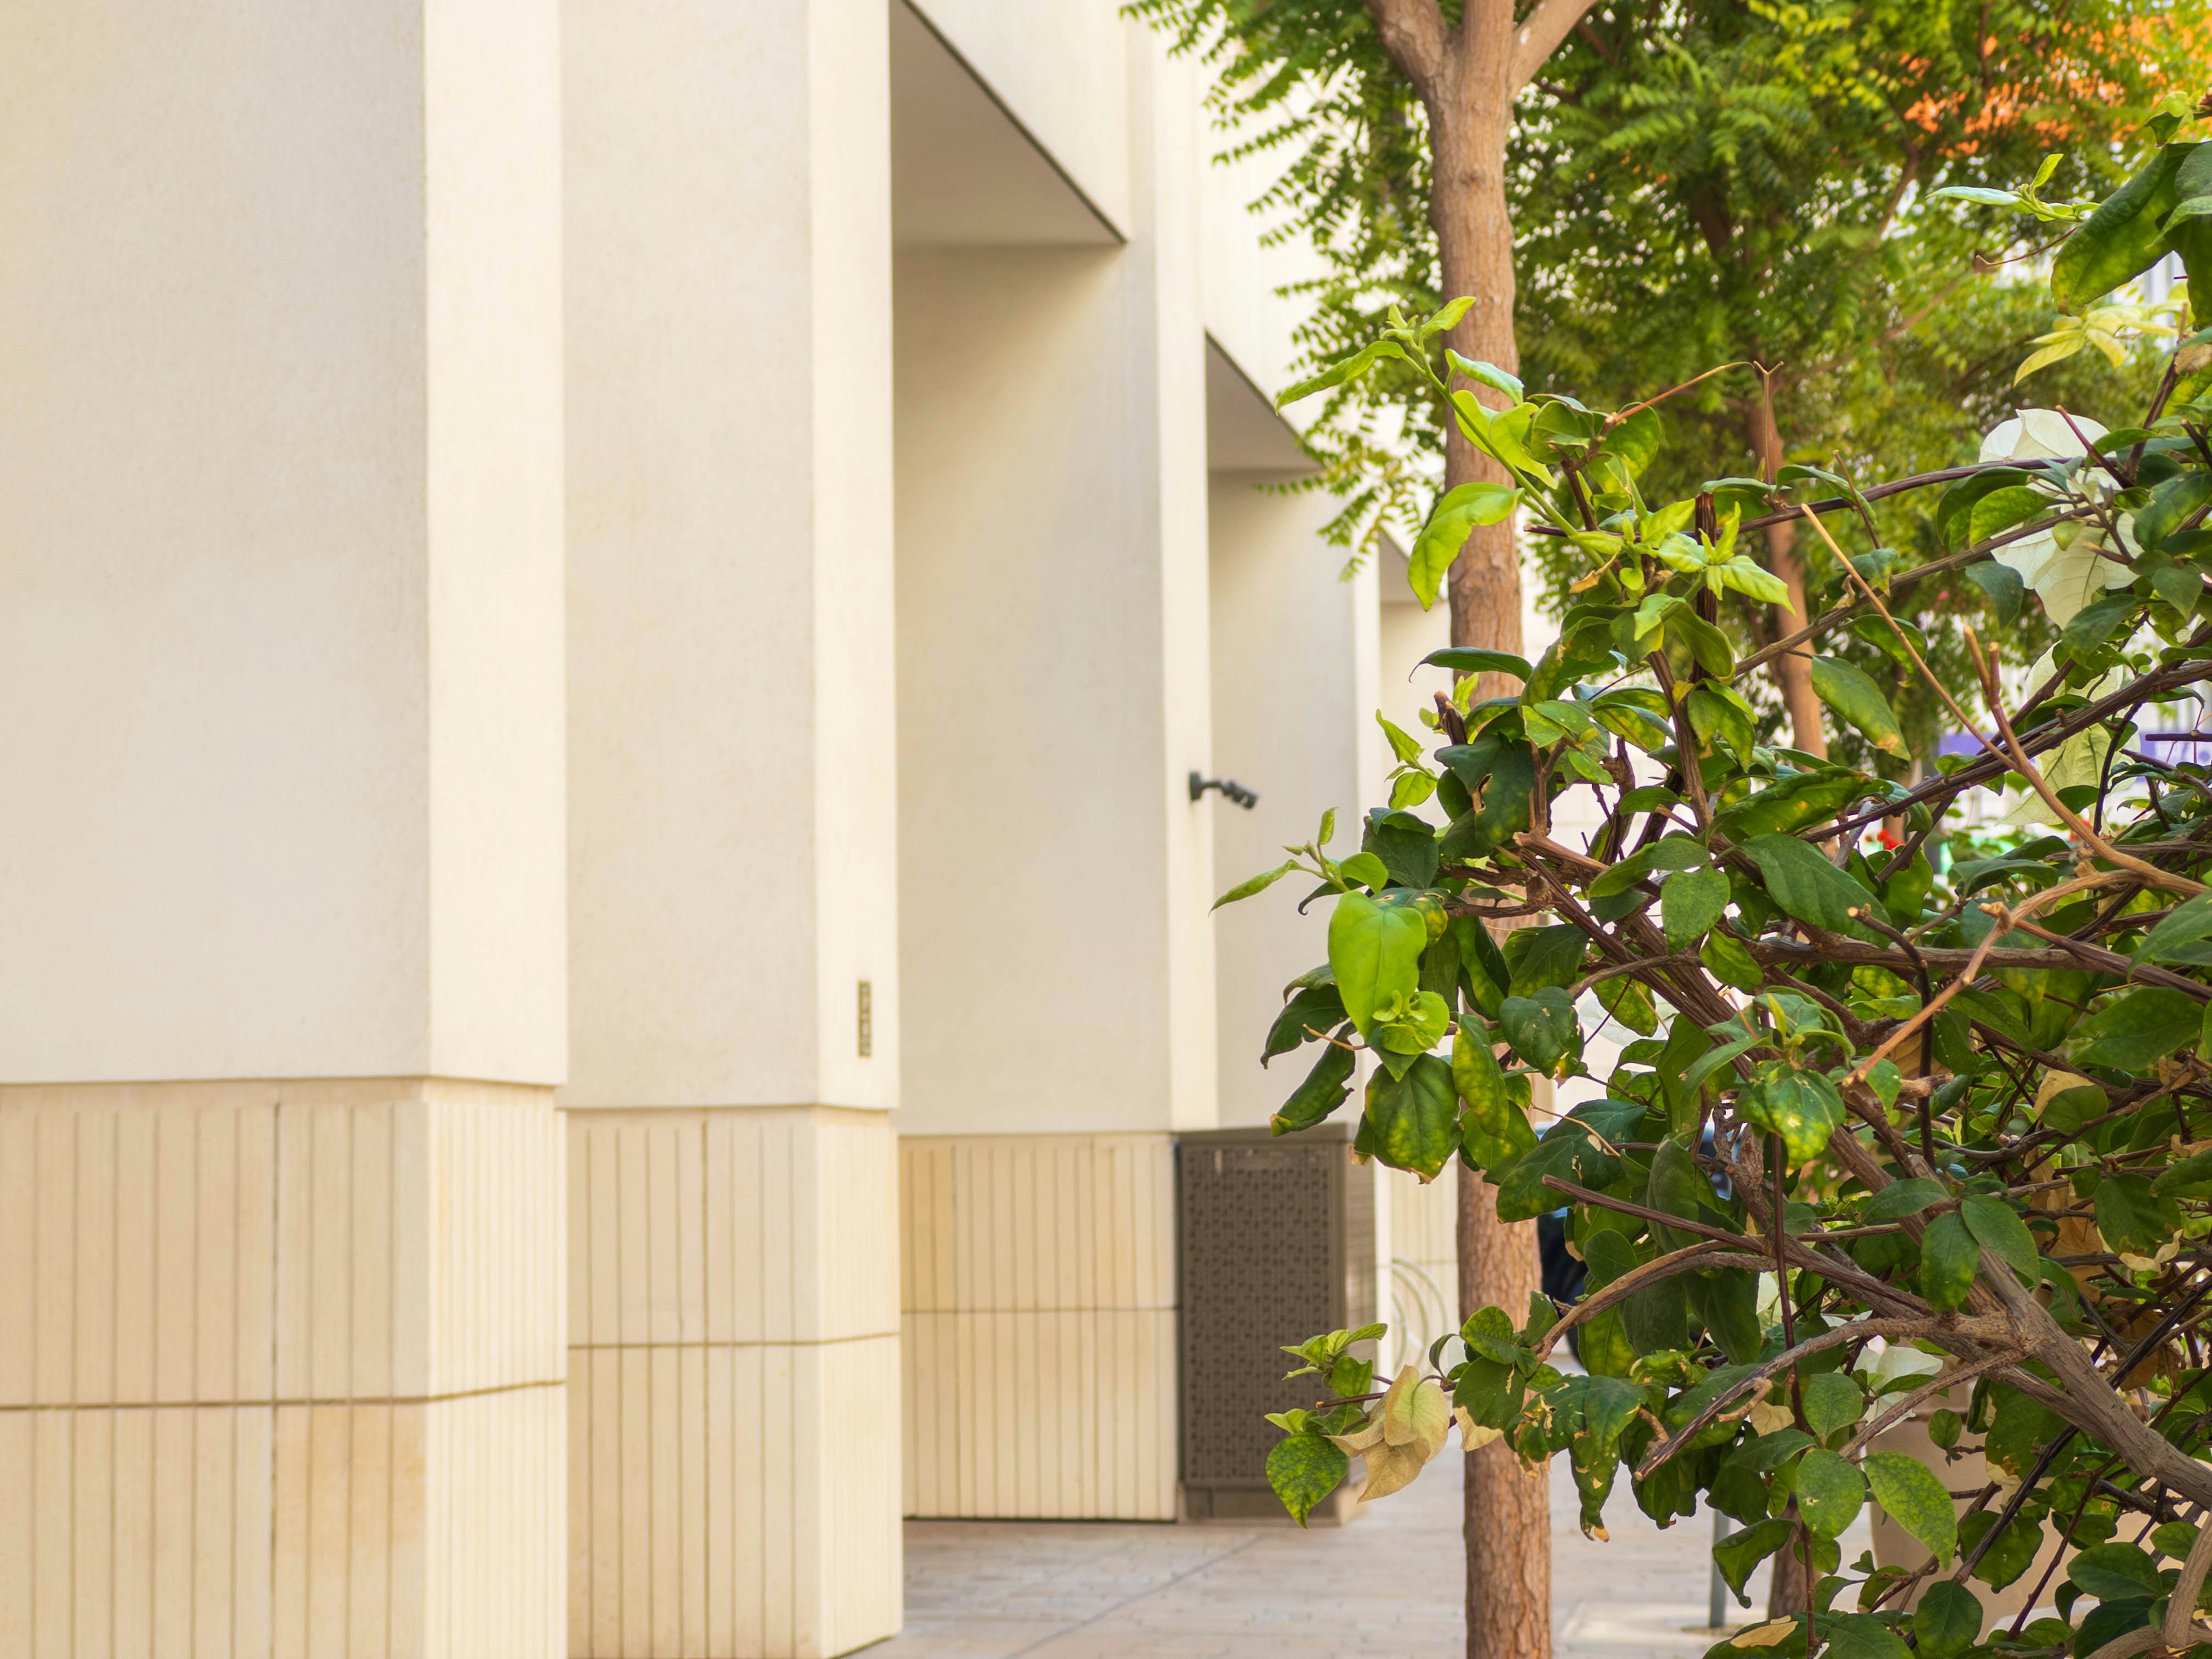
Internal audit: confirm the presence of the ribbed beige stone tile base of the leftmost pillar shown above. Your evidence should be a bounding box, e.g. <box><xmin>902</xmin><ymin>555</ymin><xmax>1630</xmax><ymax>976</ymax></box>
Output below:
<box><xmin>0</xmin><ymin>1080</ymin><xmax>566</xmax><ymax>1659</ymax></box>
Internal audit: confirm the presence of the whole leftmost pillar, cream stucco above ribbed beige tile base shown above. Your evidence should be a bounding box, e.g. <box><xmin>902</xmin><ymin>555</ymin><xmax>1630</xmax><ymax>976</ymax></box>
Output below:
<box><xmin>0</xmin><ymin>0</ymin><xmax>566</xmax><ymax>1659</ymax></box>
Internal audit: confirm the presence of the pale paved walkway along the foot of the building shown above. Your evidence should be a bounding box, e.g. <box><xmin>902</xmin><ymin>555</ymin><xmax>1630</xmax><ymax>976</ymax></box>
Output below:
<box><xmin>867</xmin><ymin>1456</ymin><xmax>1867</xmax><ymax>1659</ymax></box>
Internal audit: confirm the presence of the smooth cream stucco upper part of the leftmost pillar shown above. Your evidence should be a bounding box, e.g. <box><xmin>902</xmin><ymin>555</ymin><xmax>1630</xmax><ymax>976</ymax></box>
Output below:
<box><xmin>0</xmin><ymin>0</ymin><xmax>564</xmax><ymax>1082</ymax></box>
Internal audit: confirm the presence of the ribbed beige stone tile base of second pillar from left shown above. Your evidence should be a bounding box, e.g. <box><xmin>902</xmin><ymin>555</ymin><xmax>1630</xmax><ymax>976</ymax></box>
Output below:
<box><xmin>566</xmin><ymin>1108</ymin><xmax>900</xmax><ymax>1659</ymax></box>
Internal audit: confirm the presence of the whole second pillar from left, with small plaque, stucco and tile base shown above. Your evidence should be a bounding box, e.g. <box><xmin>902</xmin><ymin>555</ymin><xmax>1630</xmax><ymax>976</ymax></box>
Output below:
<box><xmin>562</xmin><ymin>0</ymin><xmax>905</xmax><ymax>1659</ymax></box>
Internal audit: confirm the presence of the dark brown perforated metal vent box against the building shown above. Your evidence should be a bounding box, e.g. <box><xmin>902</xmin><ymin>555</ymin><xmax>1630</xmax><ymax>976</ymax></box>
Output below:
<box><xmin>1177</xmin><ymin>1126</ymin><xmax>1376</xmax><ymax>1513</ymax></box>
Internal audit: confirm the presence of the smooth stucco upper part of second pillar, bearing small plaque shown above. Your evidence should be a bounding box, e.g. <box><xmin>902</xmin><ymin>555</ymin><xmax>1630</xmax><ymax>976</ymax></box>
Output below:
<box><xmin>564</xmin><ymin>0</ymin><xmax>900</xmax><ymax>1106</ymax></box>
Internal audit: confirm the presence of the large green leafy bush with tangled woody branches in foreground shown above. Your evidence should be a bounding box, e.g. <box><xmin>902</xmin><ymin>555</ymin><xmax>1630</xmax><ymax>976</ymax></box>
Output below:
<box><xmin>1224</xmin><ymin>122</ymin><xmax>2212</xmax><ymax>1657</ymax></box>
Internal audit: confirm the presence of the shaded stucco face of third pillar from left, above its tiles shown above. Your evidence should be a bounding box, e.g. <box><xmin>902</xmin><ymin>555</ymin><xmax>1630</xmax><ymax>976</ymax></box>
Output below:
<box><xmin>896</xmin><ymin>250</ymin><xmax>1201</xmax><ymax>1135</ymax></box>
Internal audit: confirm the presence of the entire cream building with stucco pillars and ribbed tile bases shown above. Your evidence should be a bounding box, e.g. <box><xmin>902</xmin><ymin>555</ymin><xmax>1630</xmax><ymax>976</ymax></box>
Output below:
<box><xmin>0</xmin><ymin>0</ymin><xmax>1415</xmax><ymax>1659</ymax></box>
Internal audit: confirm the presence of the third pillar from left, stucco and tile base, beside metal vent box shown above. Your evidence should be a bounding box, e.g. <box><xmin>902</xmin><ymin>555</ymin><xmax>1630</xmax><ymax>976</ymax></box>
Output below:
<box><xmin>896</xmin><ymin>19</ymin><xmax>1214</xmax><ymax>1520</ymax></box>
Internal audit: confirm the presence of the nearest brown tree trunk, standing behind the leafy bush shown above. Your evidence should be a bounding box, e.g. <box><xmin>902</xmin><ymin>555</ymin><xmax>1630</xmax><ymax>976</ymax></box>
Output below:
<box><xmin>1429</xmin><ymin>39</ymin><xmax>1551</xmax><ymax>1659</ymax></box>
